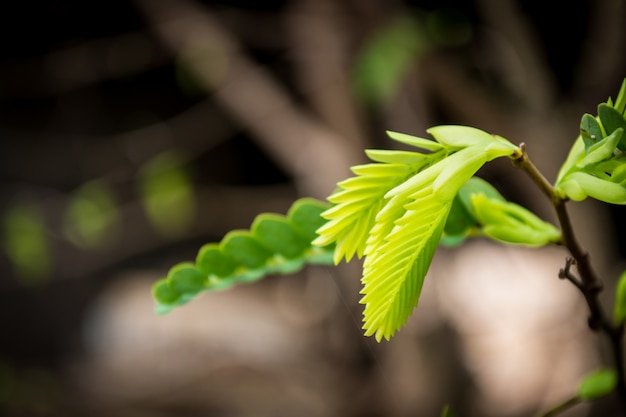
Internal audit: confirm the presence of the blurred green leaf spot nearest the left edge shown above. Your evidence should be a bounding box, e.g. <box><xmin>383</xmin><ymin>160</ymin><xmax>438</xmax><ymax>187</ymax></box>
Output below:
<box><xmin>3</xmin><ymin>202</ymin><xmax>52</xmax><ymax>286</ymax></box>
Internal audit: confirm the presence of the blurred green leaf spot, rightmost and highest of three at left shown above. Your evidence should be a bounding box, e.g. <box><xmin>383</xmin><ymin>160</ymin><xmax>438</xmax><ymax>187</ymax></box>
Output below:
<box><xmin>139</xmin><ymin>151</ymin><xmax>196</xmax><ymax>237</ymax></box>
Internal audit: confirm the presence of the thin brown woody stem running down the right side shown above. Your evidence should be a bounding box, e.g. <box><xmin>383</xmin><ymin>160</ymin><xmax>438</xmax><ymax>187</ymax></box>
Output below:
<box><xmin>513</xmin><ymin>143</ymin><xmax>626</xmax><ymax>415</ymax></box>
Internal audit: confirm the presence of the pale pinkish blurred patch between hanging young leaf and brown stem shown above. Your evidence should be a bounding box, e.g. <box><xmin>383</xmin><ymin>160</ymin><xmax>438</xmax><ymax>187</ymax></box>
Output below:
<box><xmin>436</xmin><ymin>241</ymin><xmax>599</xmax><ymax>416</ymax></box>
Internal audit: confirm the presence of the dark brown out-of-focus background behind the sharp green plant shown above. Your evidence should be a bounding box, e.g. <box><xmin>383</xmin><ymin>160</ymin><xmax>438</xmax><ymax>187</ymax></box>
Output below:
<box><xmin>0</xmin><ymin>0</ymin><xmax>626</xmax><ymax>417</ymax></box>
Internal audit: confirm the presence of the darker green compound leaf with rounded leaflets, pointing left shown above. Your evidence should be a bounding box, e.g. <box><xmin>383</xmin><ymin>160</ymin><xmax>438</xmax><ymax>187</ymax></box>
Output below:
<box><xmin>152</xmin><ymin>198</ymin><xmax>334</xmax><ymax>314</ymax></box>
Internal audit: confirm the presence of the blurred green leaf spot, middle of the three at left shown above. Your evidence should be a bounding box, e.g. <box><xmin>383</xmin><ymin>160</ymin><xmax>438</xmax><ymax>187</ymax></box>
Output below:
<box><xmin>63</xmin><ymin>182</ymin><xmax>119</xmax><ymax>249</ymax></box>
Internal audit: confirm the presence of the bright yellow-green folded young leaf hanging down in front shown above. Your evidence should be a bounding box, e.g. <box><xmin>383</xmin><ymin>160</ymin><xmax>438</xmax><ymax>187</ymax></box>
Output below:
<box><xmin>338</xmin><ymin>126</ymin><xmax>519</xmax><ymax>341</ymax></box>
